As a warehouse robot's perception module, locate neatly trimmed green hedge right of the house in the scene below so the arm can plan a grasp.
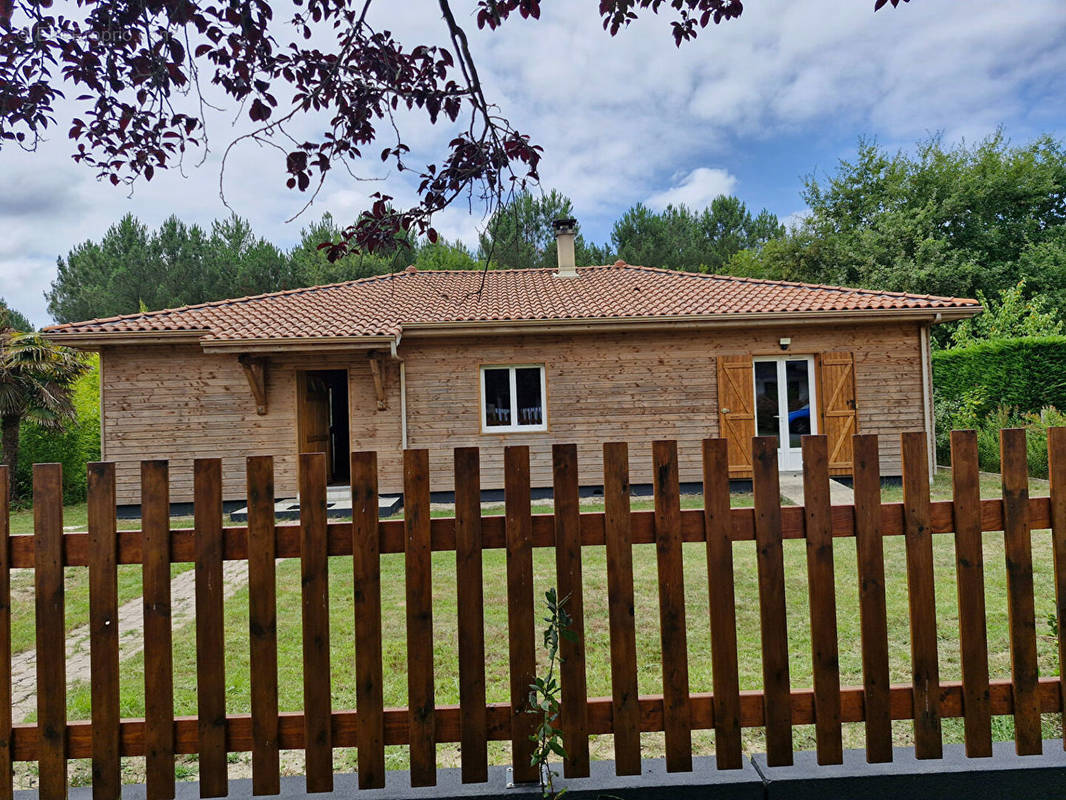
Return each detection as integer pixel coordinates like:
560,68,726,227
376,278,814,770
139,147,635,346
933,336,1066,414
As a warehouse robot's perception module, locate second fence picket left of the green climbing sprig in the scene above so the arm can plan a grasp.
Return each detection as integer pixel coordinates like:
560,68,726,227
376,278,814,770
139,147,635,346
454,447,488,783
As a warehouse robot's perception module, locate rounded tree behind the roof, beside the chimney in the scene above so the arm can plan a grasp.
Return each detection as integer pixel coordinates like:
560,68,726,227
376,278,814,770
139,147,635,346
478,189,608,269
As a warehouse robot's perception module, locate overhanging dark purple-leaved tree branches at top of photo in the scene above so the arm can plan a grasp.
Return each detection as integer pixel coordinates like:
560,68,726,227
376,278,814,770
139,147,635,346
0,0,899,258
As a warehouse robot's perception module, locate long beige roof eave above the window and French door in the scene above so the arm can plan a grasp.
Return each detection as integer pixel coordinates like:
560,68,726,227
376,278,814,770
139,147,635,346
404,306,983,337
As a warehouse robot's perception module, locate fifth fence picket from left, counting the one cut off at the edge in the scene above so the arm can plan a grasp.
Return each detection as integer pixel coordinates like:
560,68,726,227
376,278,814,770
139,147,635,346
193,459,228,797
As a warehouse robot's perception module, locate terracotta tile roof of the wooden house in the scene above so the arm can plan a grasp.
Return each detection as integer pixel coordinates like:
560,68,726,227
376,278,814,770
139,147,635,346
46,262,980,341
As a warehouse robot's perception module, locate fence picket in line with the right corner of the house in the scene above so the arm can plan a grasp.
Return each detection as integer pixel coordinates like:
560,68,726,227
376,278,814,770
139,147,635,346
900,431,943,758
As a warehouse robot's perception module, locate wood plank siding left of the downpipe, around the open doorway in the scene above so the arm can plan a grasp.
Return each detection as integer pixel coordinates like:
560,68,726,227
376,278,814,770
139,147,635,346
100,345,401,505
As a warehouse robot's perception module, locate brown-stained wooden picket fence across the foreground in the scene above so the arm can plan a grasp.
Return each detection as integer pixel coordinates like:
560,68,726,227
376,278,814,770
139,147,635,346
0,429,1066,798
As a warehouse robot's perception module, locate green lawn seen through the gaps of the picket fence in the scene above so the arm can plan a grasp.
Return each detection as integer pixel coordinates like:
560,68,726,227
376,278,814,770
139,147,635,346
10,471,1061,780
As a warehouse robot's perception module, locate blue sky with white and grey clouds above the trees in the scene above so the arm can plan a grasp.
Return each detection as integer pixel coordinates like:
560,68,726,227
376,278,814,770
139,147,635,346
0,0,1066,324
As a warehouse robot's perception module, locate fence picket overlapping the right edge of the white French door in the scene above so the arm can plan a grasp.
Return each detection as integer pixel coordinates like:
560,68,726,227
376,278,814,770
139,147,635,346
802,435,844,764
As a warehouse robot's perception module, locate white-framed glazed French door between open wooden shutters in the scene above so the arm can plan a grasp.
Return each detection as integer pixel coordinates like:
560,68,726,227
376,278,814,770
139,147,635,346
754,355,818,471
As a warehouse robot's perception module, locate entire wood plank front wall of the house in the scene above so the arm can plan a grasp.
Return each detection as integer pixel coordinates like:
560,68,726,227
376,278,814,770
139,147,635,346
101,323,925,503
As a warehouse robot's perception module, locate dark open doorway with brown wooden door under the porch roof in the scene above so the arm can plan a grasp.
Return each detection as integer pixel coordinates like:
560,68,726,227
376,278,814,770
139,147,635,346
296,369,351,483
